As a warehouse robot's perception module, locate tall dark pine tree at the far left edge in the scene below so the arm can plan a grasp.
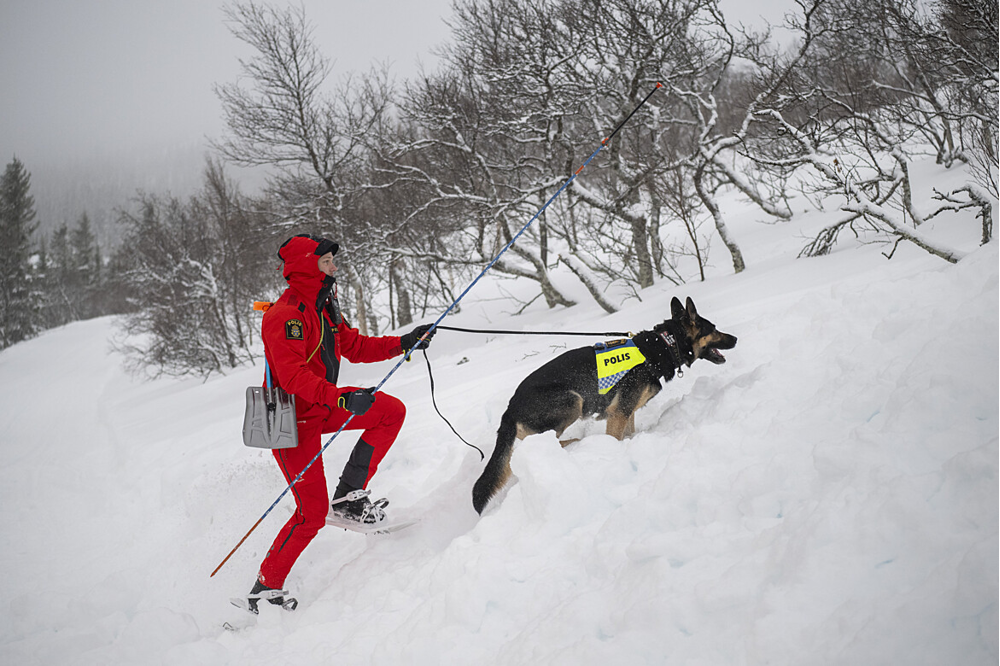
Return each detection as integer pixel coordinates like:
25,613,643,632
0,157,38,349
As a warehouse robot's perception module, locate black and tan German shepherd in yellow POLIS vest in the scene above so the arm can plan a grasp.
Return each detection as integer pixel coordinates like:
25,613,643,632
472,297,736,513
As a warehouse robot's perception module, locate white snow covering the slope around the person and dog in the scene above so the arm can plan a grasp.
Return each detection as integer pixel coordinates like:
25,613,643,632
0,158,1000,666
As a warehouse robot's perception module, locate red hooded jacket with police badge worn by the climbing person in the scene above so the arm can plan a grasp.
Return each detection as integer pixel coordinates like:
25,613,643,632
261,236,403,417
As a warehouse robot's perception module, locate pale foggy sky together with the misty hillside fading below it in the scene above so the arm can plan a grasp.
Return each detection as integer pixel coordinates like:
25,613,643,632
0,0,793,243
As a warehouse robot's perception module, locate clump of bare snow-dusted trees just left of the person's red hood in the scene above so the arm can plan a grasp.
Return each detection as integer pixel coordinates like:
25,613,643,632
115,162,278,376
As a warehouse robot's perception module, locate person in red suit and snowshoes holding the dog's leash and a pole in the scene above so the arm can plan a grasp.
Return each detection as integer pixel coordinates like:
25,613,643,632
251,235,434,610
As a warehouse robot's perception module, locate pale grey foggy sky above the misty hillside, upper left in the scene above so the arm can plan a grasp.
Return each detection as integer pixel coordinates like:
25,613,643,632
0,0,450,167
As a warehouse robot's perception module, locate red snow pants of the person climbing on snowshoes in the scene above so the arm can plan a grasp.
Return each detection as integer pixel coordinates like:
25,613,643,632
260,388,406,588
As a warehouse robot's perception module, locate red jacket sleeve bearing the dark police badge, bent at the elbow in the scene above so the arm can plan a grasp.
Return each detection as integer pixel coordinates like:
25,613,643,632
261,306,343,407
